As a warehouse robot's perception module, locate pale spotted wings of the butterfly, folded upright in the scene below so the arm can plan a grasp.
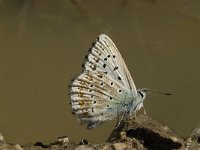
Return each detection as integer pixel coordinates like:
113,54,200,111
71,34,137,129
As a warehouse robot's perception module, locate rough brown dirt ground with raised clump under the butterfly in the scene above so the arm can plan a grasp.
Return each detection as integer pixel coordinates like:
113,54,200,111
0,115,200,150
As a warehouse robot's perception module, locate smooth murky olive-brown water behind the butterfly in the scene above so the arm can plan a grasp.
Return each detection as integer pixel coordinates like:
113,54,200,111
0,0,200,144
